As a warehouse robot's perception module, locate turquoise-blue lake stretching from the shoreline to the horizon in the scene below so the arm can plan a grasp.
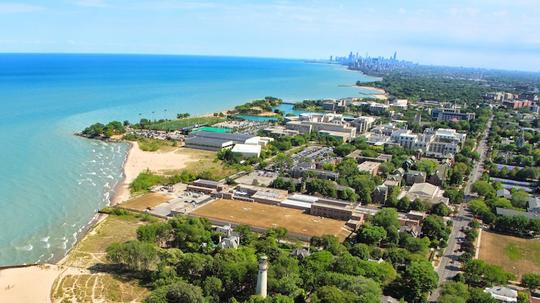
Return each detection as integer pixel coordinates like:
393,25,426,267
0,54,378,265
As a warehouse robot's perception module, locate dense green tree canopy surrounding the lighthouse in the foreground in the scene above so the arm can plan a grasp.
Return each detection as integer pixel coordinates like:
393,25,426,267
107,208,447,303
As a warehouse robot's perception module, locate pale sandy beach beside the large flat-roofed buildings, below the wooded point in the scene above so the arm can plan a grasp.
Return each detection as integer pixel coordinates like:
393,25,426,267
111,142,200,205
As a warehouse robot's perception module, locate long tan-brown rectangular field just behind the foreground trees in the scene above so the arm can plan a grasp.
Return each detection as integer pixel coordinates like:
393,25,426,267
192,199,348,239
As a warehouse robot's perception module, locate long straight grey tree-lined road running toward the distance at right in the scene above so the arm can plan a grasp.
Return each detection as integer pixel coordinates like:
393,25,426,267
429,117,493,302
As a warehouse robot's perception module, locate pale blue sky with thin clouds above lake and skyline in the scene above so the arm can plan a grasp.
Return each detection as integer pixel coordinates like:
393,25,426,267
0,0,540,71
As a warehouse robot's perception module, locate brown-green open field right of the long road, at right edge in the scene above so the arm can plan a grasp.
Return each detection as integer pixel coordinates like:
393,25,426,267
479,231,540,279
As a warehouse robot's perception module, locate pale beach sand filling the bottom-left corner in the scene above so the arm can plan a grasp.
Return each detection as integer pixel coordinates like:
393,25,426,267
0,265,63,303
